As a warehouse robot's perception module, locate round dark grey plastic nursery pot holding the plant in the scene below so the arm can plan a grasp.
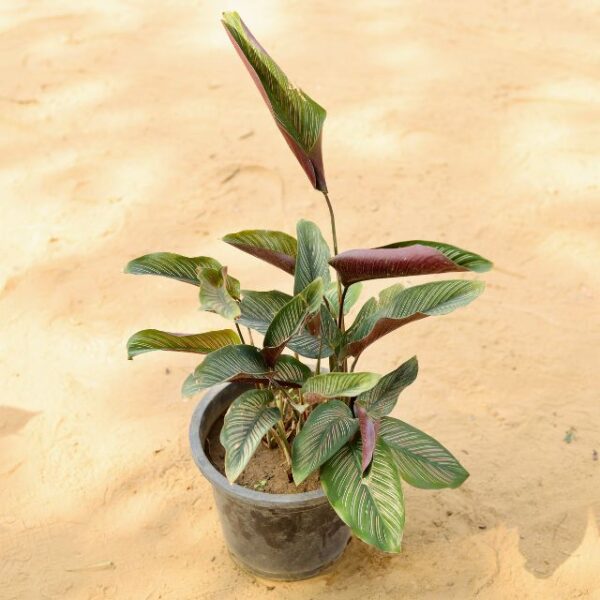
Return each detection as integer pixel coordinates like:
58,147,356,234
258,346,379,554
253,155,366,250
190,383,350,580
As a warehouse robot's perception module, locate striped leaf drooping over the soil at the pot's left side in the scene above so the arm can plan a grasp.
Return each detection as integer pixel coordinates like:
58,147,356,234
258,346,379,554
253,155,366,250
221,390,281,483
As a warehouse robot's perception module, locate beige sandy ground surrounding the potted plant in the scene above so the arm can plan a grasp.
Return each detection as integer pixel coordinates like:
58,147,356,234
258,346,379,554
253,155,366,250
0,0,600,600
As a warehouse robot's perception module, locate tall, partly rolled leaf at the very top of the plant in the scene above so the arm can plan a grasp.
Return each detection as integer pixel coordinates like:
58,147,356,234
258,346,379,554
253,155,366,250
222,12,327,191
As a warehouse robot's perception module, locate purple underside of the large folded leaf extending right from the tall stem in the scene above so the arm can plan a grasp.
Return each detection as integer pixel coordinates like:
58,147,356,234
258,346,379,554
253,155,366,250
329,244,468,286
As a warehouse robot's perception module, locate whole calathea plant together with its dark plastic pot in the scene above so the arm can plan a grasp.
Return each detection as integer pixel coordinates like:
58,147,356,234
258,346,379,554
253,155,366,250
126,13,491,579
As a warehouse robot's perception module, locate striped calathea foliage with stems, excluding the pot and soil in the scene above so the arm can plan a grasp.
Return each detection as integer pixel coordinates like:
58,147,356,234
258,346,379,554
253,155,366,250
126,13,491,552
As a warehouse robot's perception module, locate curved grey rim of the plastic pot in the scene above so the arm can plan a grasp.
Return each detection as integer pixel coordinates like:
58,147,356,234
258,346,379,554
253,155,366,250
189,383,328,509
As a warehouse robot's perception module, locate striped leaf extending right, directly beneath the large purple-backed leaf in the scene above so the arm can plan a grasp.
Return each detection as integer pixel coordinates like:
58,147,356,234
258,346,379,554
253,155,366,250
344,279,485,356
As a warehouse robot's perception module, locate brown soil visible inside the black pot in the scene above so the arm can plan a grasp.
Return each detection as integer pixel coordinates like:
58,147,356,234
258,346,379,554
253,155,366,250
205,417,321,494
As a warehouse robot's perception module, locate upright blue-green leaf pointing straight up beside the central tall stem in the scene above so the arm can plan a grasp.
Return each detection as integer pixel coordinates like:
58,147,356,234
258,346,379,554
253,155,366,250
294,219,331,294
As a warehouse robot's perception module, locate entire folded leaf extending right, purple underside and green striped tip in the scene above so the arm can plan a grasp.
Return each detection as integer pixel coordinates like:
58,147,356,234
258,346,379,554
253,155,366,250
329,241,492,285
